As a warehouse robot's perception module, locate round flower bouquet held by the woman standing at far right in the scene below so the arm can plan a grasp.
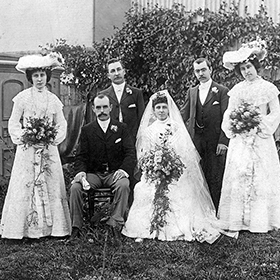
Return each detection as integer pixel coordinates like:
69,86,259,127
229,101,261,134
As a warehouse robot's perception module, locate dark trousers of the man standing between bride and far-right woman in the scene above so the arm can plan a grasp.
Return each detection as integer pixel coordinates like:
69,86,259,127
194,133,226,210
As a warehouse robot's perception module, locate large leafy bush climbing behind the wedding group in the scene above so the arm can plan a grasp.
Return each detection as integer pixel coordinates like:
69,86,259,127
49,3,280,105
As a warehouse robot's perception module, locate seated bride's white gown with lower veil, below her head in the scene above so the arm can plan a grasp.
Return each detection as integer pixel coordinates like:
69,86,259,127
122,119,220,243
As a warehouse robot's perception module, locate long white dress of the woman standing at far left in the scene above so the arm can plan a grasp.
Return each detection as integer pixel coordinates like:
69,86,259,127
0,87,71,239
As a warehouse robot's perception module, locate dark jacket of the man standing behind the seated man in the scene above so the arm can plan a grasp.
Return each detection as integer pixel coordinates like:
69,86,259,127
99,84,145,141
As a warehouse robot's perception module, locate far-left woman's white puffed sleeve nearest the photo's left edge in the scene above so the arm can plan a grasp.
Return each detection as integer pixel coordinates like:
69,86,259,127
8,97,23,145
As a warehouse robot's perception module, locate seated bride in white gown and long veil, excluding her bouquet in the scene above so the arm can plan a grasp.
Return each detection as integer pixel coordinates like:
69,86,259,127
122,90,220,243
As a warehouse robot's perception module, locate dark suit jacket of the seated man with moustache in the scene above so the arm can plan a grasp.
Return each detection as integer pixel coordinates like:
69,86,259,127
75,120,136,176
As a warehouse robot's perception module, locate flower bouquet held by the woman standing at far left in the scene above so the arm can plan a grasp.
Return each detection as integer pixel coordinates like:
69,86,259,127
21,116,57,148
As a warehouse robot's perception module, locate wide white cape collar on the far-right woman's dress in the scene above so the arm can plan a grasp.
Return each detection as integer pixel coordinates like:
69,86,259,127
228,77,279,106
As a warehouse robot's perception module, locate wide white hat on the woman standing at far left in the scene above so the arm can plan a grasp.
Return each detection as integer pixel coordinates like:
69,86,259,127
16,52,64,73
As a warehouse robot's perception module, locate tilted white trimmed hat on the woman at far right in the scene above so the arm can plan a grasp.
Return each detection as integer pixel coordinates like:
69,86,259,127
223,38,267,70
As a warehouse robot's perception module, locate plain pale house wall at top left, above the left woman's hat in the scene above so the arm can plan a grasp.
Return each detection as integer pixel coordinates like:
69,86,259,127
0,0,131,53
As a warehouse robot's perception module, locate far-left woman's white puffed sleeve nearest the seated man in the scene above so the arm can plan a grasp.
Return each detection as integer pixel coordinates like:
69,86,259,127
51,98,67,145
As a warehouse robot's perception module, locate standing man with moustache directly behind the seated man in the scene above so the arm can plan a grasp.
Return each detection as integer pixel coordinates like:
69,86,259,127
100,58,145,142
